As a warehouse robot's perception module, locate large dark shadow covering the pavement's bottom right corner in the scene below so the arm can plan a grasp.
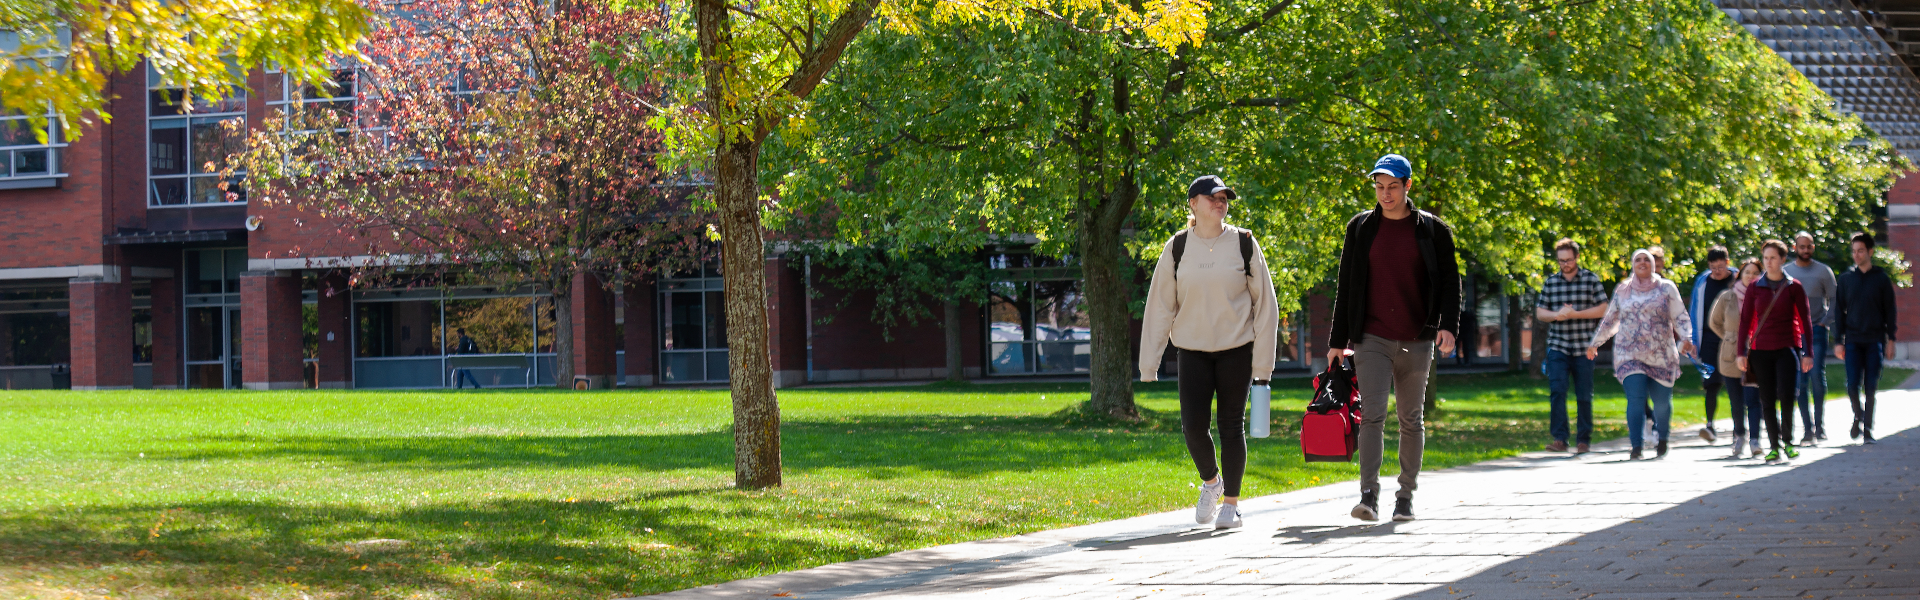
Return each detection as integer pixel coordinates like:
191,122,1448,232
1397,431,1920,600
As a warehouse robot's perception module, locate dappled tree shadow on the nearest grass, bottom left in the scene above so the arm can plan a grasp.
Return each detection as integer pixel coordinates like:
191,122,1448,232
0,490,952,598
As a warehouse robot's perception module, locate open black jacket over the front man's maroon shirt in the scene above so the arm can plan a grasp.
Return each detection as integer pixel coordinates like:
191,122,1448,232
1327,208,1459,348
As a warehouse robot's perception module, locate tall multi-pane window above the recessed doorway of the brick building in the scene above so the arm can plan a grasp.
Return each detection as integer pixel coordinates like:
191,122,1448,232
146,67,246,206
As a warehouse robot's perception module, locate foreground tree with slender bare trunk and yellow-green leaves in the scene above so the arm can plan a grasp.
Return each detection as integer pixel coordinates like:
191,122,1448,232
652,0,1206,488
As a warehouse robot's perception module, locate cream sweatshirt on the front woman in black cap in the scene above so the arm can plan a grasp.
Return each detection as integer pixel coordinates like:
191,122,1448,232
1140,225,1281,381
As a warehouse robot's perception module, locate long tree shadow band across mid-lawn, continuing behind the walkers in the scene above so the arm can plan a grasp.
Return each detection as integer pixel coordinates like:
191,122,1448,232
144,402,1613,479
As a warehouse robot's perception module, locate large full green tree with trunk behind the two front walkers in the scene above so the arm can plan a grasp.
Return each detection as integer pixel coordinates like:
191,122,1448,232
778,0,1893,417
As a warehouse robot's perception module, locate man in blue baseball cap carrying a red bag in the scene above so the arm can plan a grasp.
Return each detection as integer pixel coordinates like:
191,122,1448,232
1327,154,1459,521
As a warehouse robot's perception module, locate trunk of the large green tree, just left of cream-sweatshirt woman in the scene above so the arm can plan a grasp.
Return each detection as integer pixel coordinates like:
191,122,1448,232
1079,181,1140,419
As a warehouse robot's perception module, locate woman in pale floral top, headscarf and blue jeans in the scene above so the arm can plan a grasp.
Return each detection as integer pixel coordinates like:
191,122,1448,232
1586,250,1693,460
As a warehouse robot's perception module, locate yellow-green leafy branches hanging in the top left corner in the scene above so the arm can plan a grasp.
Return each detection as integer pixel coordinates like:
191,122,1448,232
0,0,372,138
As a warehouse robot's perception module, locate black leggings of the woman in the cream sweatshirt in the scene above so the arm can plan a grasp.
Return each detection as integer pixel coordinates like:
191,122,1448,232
1181,344,1254,498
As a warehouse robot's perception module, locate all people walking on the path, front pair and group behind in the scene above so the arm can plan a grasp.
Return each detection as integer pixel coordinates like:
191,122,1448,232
1139,154,1895,529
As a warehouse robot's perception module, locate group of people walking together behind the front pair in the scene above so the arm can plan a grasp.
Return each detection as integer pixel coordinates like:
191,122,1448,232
1534,233,1895,463
